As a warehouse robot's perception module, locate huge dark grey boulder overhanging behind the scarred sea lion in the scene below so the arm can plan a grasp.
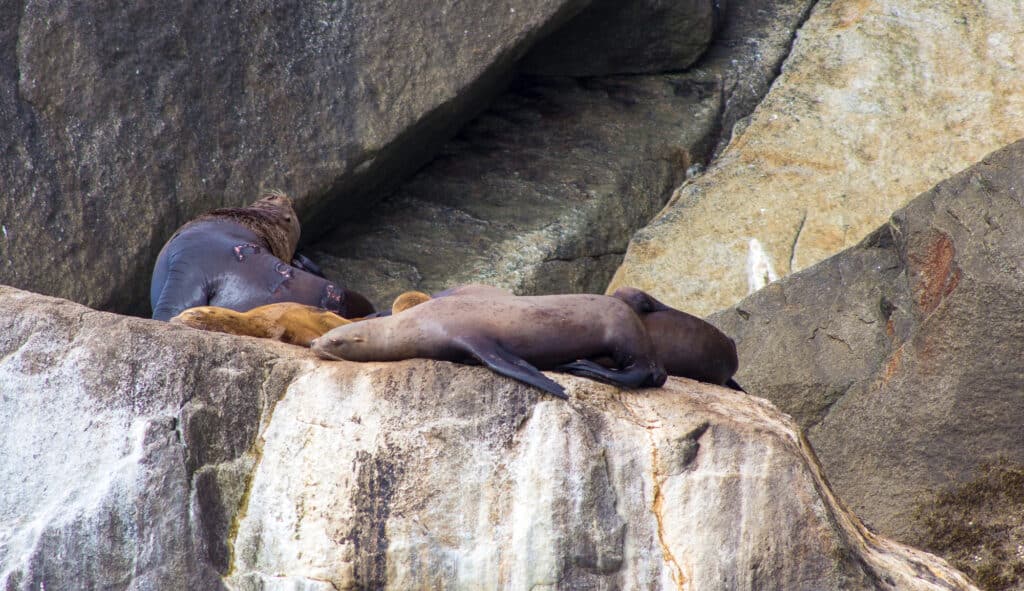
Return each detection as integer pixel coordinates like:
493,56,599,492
0,0,587,313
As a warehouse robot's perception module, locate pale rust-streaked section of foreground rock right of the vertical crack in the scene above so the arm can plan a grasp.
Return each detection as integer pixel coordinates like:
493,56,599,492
228,361,972,590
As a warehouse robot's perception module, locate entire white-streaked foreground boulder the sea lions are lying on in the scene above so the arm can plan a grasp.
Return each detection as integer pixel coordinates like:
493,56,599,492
0,288,975,591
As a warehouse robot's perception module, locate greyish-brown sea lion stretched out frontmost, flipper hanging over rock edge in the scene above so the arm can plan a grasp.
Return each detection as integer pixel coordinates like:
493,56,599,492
311,293,666,398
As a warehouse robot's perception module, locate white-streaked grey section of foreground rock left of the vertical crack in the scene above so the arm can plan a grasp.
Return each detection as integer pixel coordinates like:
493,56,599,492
0,287,307,591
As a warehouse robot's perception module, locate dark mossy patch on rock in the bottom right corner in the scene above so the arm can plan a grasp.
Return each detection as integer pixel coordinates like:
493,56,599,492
918,458,1024,591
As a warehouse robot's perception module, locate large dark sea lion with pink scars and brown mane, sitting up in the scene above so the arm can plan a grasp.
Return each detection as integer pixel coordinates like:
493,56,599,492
150,193,374,321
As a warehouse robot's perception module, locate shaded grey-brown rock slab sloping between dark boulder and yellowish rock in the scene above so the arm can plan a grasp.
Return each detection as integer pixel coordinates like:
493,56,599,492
303,0,810,306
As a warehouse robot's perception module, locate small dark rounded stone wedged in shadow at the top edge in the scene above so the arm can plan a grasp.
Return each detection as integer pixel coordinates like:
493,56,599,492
520,0,721,76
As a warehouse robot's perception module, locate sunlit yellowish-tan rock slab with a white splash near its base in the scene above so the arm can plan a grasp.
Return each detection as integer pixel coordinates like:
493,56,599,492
609,0,1024,314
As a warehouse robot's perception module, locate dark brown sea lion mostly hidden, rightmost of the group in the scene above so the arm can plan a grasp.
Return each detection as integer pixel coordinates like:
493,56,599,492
611,287,744,391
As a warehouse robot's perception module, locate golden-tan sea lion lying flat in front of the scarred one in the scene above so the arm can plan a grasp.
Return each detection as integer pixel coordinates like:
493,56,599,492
170,302,352,347
